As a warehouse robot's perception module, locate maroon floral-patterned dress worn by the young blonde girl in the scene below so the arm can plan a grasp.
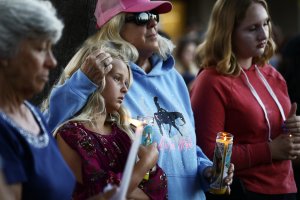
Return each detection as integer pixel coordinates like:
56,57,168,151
57,122,167,200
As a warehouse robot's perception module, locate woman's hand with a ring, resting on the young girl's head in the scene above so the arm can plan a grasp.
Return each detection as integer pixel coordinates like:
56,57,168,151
80,49,113,86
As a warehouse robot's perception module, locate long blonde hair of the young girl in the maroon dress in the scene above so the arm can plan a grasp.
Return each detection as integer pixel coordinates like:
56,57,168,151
43,41,135,137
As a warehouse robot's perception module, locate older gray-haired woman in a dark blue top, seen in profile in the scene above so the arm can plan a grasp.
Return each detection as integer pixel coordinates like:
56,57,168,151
0,0,75,200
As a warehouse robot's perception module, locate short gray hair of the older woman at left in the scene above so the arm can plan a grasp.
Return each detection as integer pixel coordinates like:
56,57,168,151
0,0,63,58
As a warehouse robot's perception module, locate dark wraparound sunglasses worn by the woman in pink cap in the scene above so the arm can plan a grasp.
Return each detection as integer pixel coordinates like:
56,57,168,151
125,12,159,26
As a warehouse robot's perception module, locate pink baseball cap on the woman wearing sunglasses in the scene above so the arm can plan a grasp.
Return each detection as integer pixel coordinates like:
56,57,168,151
95,0,172,28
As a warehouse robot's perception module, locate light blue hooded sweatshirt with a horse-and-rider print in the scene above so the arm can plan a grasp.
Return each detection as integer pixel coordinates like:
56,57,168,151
45,55,212,200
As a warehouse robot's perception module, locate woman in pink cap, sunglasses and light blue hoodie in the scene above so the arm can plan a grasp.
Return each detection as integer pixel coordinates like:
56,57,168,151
46,0,234,200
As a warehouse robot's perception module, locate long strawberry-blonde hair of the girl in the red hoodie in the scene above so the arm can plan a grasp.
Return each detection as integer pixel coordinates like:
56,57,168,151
197,0,276,76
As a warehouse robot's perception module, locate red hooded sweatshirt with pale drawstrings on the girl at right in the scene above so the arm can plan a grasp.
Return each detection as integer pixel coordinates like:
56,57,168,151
191,65,297,194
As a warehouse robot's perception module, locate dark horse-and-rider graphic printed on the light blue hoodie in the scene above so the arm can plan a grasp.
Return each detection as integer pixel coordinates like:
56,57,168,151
154,97,186,137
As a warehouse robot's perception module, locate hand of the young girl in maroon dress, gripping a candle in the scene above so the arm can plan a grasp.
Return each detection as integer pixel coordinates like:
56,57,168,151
138,143,158,170
